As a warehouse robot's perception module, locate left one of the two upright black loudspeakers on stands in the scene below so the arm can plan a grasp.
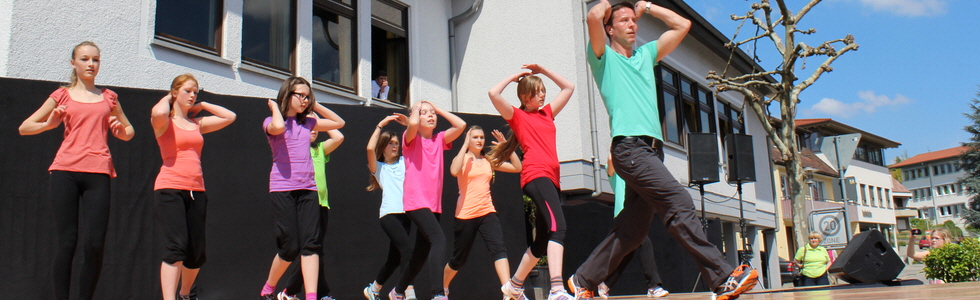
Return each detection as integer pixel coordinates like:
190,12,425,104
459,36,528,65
687,133,720,184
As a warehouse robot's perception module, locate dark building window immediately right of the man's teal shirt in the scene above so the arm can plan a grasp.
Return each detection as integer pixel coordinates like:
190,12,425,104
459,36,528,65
656,66,715,145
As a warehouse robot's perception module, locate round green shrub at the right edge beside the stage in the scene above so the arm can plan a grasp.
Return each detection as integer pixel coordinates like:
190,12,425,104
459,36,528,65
923,238,980,282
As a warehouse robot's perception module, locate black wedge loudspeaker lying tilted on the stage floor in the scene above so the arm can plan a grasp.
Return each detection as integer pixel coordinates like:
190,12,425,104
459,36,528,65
828,230,905,283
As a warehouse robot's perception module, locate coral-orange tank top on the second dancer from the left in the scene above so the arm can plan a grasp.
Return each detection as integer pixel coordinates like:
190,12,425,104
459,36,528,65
153,120,204,192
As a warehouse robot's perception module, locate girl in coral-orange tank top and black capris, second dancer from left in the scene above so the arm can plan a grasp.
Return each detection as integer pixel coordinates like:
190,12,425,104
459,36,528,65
150,74,235,300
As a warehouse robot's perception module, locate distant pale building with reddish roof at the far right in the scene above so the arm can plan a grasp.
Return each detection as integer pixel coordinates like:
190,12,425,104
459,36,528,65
888,146,970,232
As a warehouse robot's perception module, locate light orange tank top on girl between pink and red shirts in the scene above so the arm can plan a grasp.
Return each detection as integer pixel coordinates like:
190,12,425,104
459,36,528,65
456,154,497,220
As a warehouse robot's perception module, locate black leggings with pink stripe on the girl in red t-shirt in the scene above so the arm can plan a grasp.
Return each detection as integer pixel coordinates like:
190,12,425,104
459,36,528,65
524,177,565,258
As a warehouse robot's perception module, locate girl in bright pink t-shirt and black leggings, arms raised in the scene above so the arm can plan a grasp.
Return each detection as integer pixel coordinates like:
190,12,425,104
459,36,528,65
388,101,466,300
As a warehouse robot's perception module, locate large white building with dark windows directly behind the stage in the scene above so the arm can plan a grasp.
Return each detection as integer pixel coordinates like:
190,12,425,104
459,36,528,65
0,0,780,286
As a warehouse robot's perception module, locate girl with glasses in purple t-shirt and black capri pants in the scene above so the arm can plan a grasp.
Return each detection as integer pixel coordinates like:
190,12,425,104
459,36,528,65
260,76,344,300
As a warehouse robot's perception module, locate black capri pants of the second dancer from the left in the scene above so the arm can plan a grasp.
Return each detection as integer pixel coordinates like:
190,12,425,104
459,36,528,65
153,189,208,269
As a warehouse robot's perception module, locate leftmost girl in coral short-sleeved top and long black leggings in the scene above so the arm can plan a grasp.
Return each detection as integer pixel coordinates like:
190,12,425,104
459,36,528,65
19,41,134,299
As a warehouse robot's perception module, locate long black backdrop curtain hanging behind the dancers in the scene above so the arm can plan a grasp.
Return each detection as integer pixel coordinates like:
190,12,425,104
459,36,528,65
0,78,712,299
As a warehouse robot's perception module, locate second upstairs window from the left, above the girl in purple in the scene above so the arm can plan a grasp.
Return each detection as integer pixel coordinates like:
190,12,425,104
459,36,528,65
242,0,296,73
